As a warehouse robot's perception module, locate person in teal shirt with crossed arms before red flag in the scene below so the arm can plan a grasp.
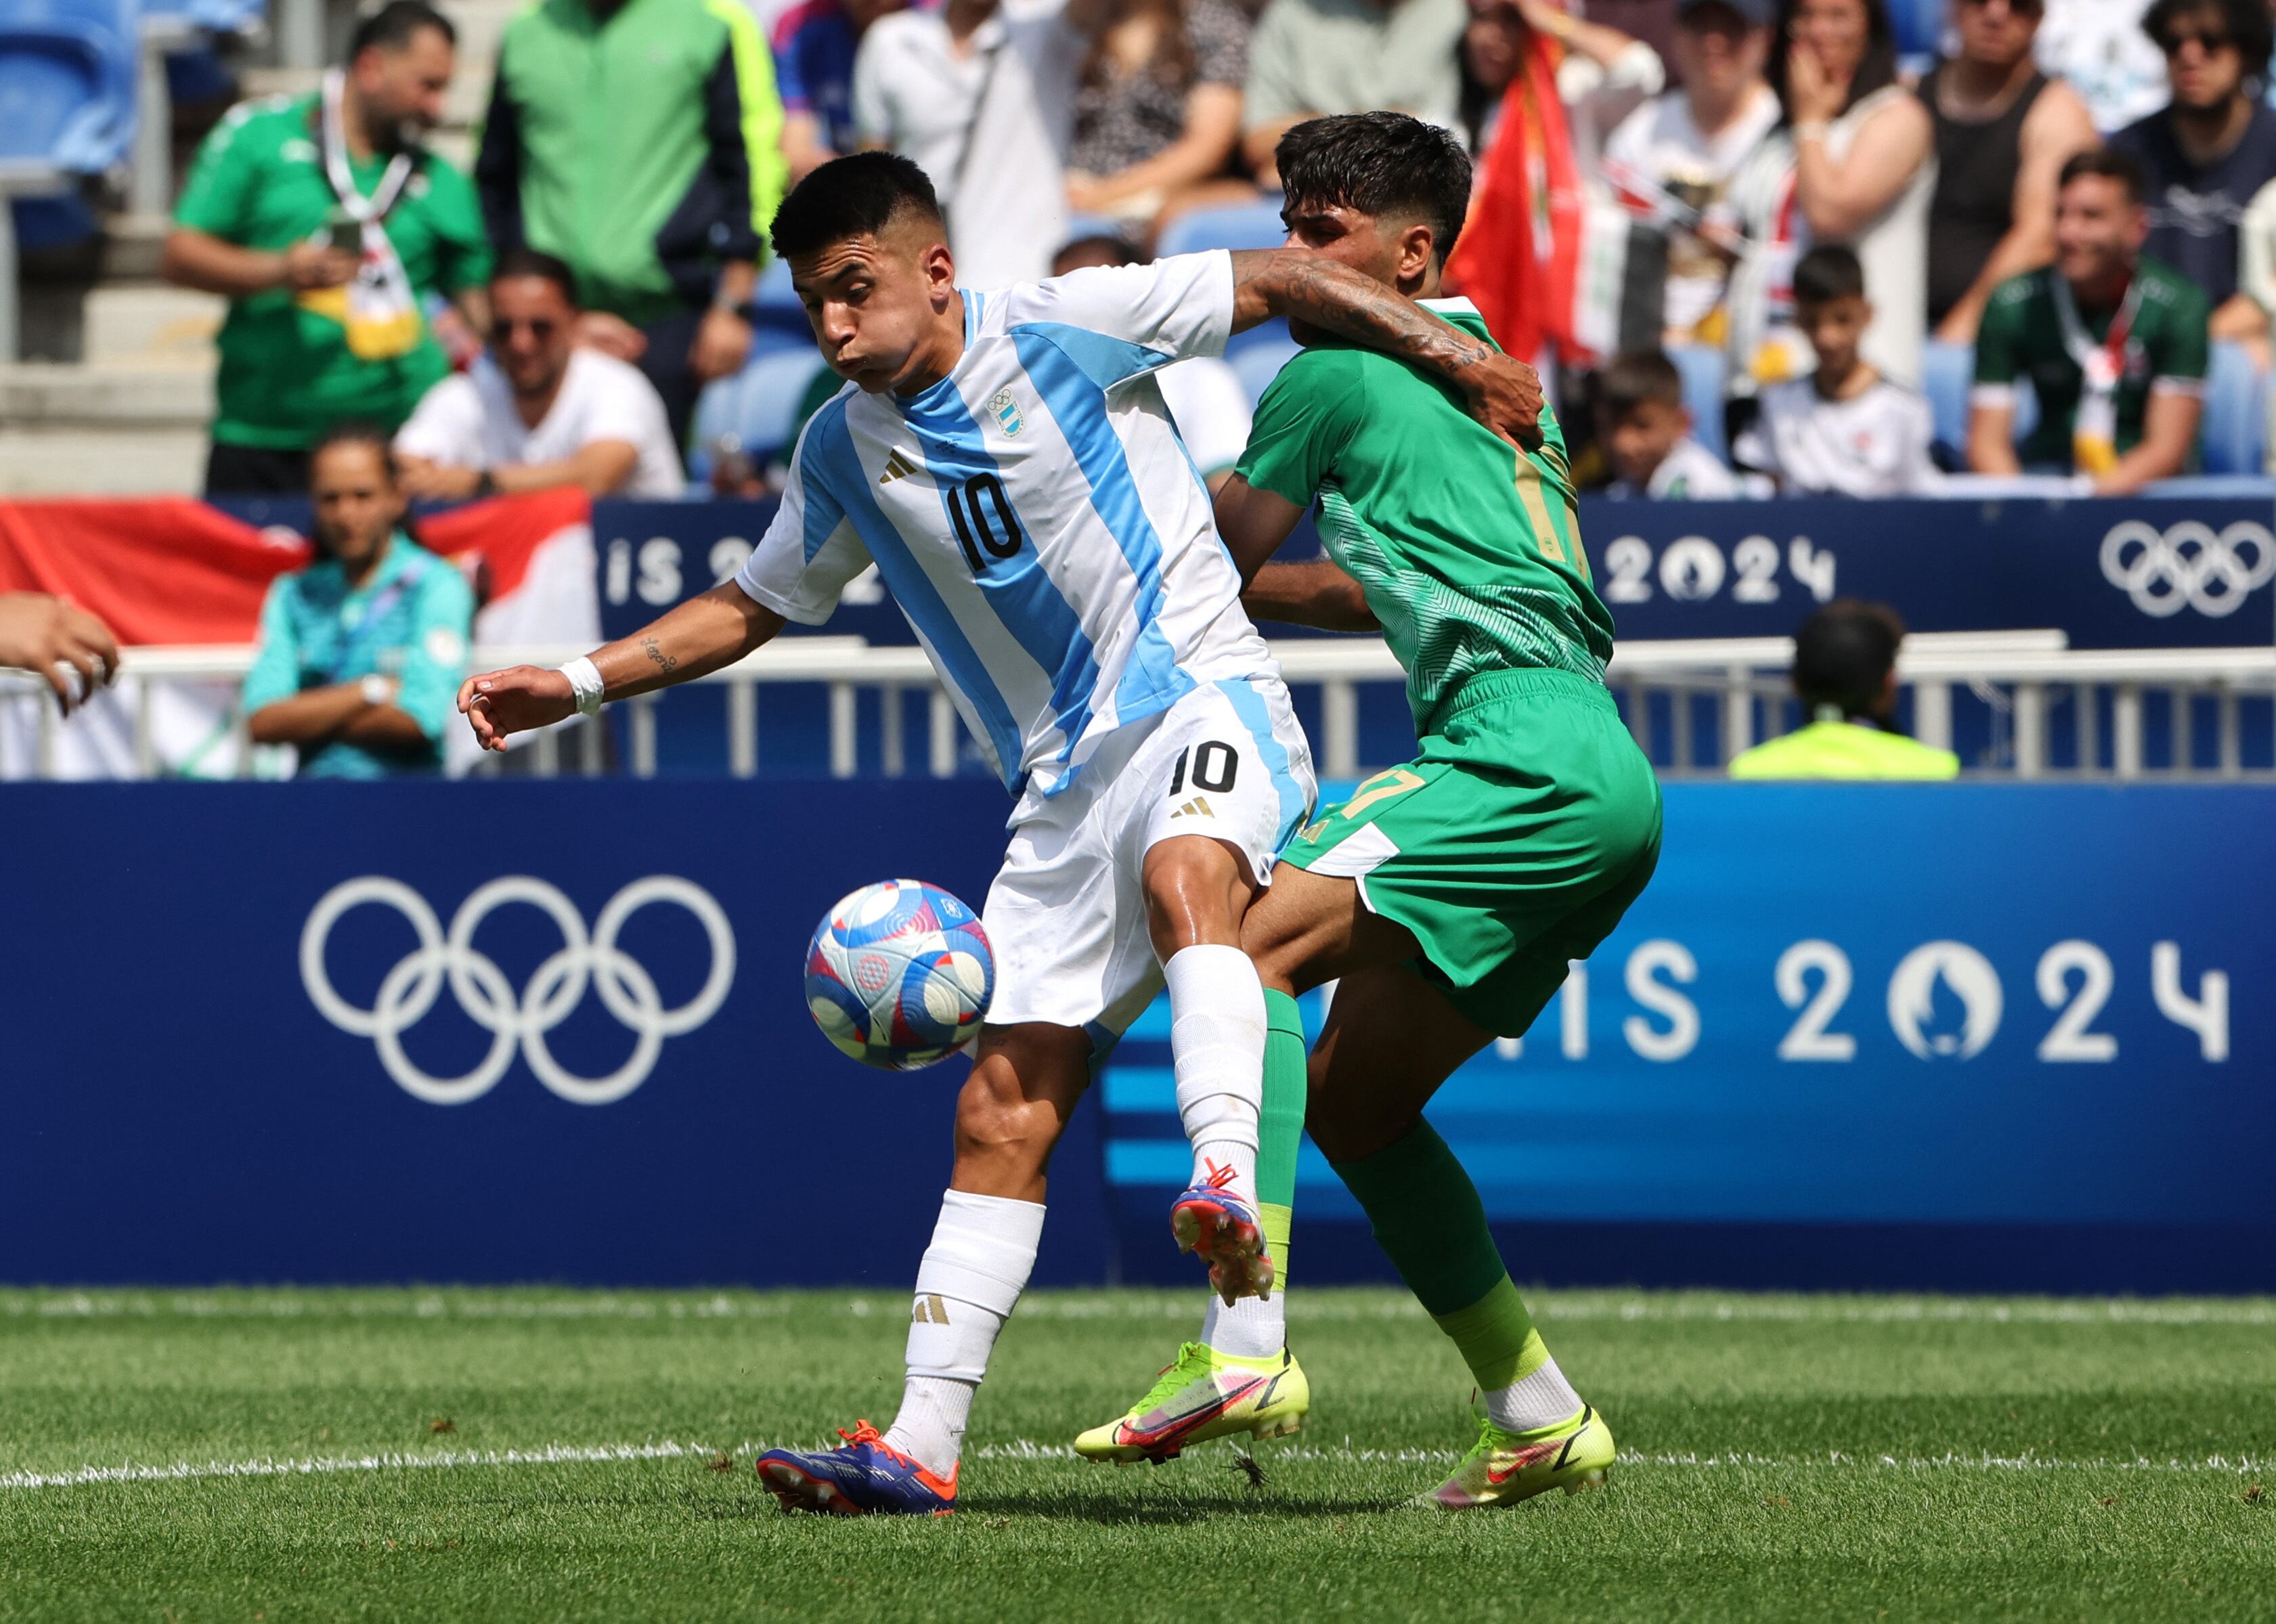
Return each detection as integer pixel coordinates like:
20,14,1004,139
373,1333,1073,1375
241,425,473,778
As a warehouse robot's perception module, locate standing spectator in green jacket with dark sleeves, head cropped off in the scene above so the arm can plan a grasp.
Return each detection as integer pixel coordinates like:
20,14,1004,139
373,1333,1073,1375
473,0,783,446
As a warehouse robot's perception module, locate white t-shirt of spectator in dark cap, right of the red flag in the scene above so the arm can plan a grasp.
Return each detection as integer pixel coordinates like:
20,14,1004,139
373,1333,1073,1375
1604,84,1778,343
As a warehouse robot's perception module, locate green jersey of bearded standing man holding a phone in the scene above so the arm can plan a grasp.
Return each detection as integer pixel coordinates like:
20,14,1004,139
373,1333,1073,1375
173,95,489,450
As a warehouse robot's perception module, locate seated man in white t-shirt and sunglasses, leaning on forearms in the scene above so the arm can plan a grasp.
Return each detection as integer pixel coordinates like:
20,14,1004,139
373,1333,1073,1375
396,248,687,503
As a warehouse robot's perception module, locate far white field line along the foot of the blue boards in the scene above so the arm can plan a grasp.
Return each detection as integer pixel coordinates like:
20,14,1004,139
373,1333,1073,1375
0,1290,2276,1326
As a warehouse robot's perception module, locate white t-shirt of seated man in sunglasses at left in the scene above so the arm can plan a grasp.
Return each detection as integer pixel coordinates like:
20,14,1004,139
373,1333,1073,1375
396,350,687,500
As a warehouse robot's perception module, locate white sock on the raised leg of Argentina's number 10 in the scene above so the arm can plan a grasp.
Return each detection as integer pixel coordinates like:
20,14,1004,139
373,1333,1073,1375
1161,946,1265,1208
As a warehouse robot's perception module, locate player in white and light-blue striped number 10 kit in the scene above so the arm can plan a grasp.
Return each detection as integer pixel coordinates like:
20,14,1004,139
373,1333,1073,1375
460,152,1541,1512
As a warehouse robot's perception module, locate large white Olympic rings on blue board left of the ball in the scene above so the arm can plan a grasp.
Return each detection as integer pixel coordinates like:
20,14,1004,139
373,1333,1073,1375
301,873,735,1105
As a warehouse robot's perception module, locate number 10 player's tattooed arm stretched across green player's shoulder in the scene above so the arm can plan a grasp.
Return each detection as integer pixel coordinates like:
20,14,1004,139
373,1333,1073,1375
1233,248,1541,450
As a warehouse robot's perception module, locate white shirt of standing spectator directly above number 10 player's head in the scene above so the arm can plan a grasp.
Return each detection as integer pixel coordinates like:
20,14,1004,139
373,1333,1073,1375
854,9,1081,286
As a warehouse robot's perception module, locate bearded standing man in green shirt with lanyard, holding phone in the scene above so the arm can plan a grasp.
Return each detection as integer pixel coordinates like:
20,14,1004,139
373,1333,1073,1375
164,0,489,496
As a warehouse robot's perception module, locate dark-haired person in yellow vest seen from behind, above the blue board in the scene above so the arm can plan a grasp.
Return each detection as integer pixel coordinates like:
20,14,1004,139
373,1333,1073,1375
1730,598,1960,778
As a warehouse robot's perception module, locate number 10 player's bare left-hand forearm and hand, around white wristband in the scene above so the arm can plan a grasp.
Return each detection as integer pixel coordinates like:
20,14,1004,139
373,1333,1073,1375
458,580,783,751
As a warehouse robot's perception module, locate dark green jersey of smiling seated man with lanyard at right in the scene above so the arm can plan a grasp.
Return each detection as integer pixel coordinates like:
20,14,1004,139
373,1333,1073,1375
1975,259,2208,468
